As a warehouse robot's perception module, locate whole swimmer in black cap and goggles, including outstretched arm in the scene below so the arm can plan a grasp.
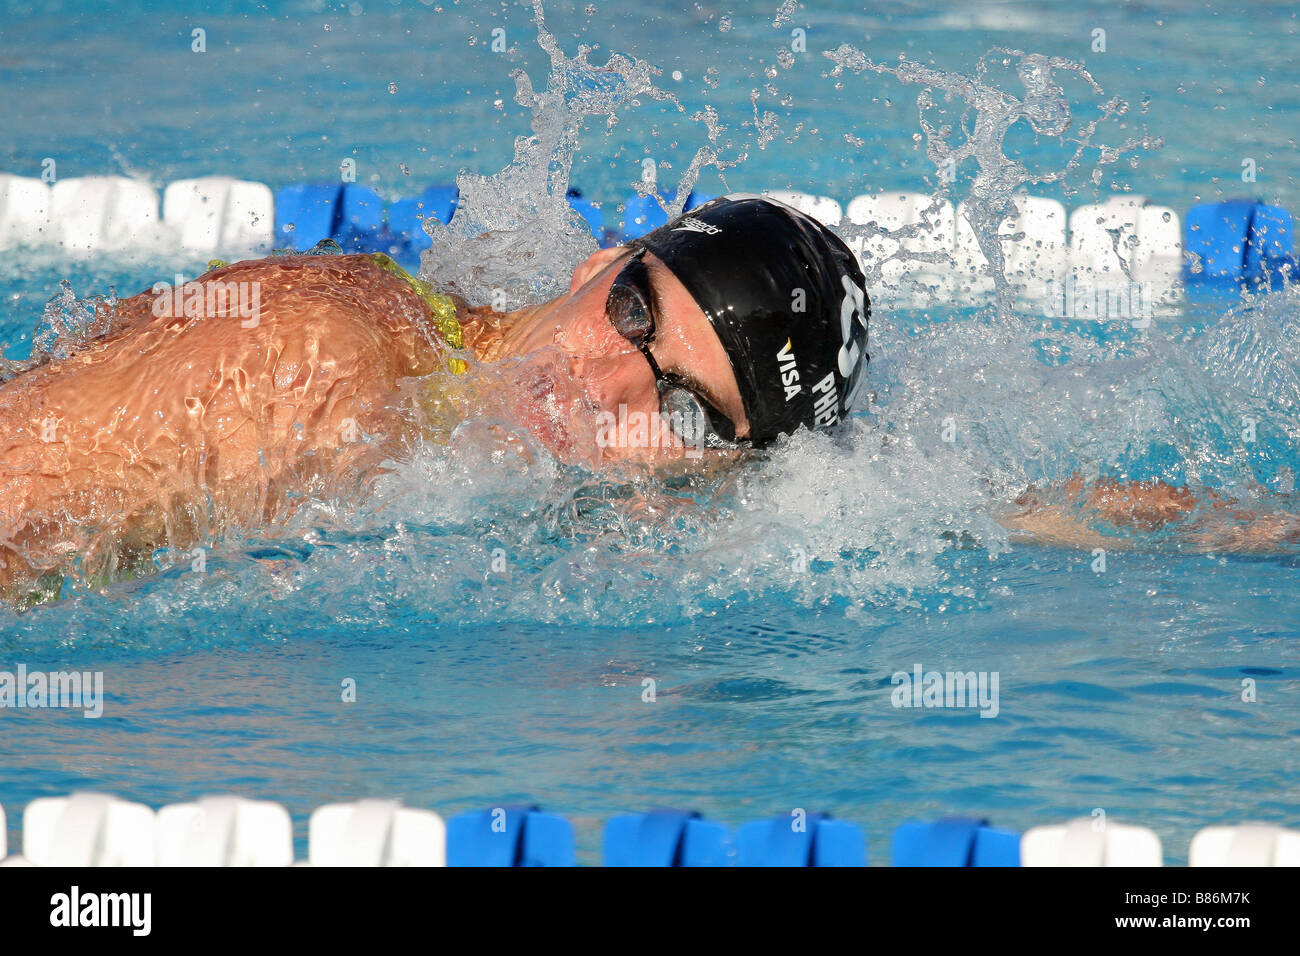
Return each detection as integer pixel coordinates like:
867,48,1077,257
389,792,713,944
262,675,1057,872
0,194,1300,601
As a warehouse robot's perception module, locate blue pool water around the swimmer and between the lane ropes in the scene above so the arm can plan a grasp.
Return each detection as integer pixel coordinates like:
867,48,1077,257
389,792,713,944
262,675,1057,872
0,0,1300,862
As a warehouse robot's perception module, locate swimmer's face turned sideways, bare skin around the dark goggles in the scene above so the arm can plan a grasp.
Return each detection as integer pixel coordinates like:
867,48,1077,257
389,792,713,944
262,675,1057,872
517,247,749,462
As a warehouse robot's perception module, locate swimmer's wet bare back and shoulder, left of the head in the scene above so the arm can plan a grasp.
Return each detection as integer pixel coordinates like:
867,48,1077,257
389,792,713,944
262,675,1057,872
0,255,462,598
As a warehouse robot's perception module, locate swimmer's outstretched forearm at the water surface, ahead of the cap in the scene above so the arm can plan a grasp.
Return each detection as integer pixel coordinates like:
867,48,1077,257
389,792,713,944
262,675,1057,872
998,476,1300,553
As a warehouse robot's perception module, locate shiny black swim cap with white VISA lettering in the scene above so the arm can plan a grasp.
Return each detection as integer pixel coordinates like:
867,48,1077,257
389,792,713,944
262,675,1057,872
628,193,871,446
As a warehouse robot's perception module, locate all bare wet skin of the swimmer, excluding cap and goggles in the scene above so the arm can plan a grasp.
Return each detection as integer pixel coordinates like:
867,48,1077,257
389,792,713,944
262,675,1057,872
0,248,1297,594
